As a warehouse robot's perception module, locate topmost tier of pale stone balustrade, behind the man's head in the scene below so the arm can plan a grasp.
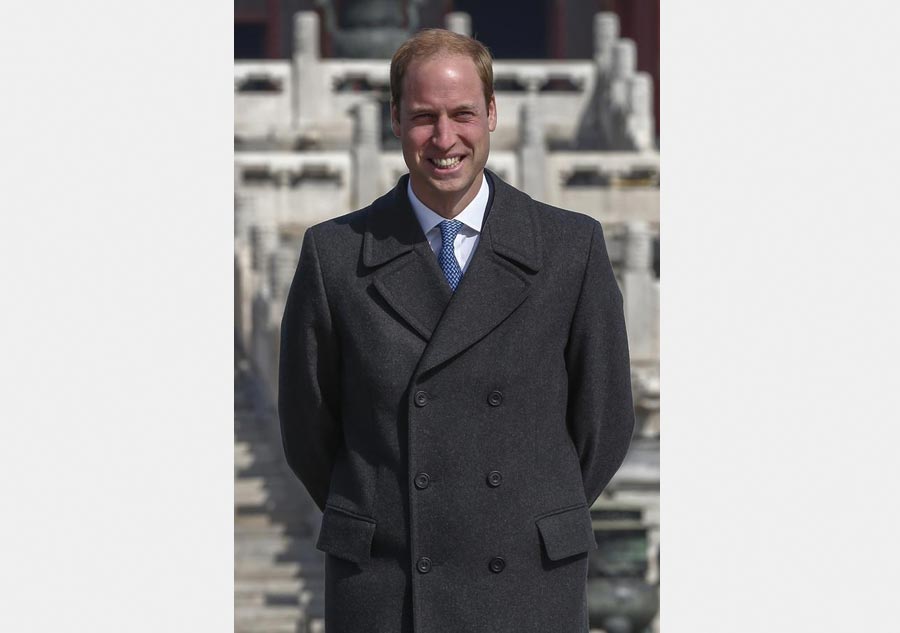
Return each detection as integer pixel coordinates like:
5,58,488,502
234,12,654,150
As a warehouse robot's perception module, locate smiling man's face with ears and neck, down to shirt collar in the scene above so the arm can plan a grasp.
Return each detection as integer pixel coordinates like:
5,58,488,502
391,56,497,217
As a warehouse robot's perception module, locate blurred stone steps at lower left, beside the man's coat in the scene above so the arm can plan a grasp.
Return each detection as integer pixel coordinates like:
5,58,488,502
234,350,325,633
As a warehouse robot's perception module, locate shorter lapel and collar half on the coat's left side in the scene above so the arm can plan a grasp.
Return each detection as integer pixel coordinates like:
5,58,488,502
363,176,453,341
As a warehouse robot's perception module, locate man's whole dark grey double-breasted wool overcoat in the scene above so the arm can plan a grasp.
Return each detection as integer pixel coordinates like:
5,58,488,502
278,172,634,633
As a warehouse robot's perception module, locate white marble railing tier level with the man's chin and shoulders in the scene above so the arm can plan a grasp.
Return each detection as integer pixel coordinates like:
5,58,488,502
235,150,659,233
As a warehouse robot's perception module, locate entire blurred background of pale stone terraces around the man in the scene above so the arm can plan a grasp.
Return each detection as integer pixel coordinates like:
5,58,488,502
234,0,660,633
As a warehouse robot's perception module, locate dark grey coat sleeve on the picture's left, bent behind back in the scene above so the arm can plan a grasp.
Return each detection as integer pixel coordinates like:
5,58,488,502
278,230,343,510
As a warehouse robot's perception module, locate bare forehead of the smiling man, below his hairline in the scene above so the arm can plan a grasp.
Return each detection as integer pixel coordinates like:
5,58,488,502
402,55,484,101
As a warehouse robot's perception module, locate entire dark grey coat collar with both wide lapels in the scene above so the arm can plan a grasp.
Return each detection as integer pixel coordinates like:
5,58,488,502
363,171,542,374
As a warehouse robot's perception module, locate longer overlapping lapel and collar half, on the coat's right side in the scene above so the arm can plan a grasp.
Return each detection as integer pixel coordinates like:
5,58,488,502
418,171,541,374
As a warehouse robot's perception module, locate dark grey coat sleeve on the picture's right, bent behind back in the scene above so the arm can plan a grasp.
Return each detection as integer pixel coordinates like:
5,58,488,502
566,222,634,506
